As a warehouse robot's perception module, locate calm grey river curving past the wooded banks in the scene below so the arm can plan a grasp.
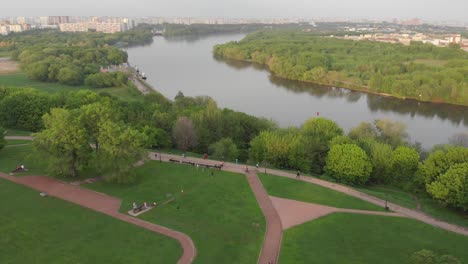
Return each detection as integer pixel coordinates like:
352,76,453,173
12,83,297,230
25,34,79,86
127,34,468,148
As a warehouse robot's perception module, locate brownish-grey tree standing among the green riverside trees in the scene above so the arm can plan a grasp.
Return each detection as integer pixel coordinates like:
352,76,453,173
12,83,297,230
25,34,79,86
172,116,197,151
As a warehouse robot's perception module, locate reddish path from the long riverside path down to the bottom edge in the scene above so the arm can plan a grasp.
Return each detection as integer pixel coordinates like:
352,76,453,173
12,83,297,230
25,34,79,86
246,172,283,264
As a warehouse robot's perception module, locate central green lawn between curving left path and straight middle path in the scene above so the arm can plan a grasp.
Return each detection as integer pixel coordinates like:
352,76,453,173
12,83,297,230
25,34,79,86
85,161,265,263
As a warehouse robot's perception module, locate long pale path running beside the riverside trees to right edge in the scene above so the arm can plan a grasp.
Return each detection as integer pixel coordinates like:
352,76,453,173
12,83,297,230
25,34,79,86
149,152,468,236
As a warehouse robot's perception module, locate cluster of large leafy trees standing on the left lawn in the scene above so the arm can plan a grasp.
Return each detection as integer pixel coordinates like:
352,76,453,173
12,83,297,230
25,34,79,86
33,100,146,183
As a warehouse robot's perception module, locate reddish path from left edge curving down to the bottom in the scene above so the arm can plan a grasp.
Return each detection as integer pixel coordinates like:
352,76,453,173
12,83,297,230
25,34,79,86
0,173,196,264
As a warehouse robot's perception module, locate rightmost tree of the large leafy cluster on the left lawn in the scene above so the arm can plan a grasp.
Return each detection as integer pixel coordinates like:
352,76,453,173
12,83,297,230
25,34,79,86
97,122,147,183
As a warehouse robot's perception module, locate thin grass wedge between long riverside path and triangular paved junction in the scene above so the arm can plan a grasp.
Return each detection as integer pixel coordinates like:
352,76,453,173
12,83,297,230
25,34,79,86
258,173,385,211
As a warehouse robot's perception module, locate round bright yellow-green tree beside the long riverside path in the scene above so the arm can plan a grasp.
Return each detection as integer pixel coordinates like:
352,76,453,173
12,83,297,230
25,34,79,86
325,144,372,184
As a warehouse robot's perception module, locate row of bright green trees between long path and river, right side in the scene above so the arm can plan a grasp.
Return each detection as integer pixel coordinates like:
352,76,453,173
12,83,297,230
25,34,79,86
249,118,468,210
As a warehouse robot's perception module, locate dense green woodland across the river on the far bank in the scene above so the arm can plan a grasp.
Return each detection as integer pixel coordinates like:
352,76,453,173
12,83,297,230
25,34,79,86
214,31,468,105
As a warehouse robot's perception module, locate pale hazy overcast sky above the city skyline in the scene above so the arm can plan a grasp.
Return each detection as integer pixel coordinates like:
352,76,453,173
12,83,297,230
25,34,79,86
0,0,468,22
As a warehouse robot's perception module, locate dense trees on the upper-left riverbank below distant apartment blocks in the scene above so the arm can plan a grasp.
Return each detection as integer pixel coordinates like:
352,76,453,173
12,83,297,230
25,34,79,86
0,27,152,88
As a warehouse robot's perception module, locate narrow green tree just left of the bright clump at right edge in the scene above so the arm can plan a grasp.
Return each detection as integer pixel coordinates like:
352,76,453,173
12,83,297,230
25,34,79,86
391,146,419,184
